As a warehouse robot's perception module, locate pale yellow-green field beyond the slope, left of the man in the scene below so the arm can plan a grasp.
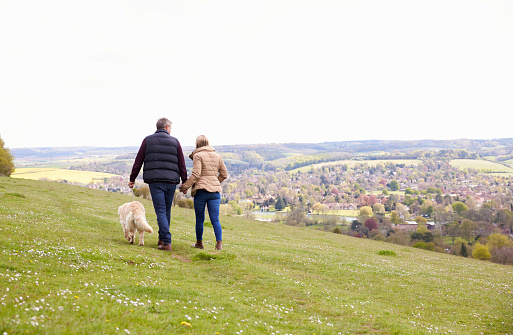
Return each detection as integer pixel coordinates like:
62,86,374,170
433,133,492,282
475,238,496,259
11,167,116,184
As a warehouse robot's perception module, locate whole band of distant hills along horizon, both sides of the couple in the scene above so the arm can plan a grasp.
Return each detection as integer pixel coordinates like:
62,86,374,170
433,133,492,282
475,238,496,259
11,138,513,171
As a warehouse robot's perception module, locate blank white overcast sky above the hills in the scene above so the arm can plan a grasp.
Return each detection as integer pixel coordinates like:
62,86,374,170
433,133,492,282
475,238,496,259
0,0,513,148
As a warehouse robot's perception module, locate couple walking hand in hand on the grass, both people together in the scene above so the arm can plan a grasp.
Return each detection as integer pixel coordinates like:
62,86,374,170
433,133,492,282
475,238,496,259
128,118,228,251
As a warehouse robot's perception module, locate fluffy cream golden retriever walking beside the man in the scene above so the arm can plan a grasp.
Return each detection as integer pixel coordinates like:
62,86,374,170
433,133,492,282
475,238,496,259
118,201,153,245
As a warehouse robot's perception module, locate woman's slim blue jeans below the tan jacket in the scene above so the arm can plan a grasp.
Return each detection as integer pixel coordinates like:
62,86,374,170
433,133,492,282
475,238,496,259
194,190,223,241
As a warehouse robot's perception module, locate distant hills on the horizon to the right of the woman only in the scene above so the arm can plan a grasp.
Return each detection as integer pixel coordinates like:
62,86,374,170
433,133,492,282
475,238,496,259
216,138,513,170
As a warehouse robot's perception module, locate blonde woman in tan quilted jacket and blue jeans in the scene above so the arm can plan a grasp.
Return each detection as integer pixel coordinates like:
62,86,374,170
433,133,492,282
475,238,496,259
180,135,228,250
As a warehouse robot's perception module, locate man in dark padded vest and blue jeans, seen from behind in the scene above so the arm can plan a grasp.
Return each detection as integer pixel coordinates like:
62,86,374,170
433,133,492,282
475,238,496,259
128,118,187,251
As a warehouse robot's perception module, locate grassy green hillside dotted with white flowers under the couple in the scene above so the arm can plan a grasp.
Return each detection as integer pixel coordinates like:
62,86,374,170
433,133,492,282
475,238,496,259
0,178,513,335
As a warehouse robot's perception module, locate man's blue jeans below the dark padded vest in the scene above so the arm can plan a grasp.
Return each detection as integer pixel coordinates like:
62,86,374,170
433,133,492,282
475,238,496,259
149,183,176,244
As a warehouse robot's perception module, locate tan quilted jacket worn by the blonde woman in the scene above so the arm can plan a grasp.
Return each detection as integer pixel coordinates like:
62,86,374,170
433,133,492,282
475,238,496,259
182,146,228,196
